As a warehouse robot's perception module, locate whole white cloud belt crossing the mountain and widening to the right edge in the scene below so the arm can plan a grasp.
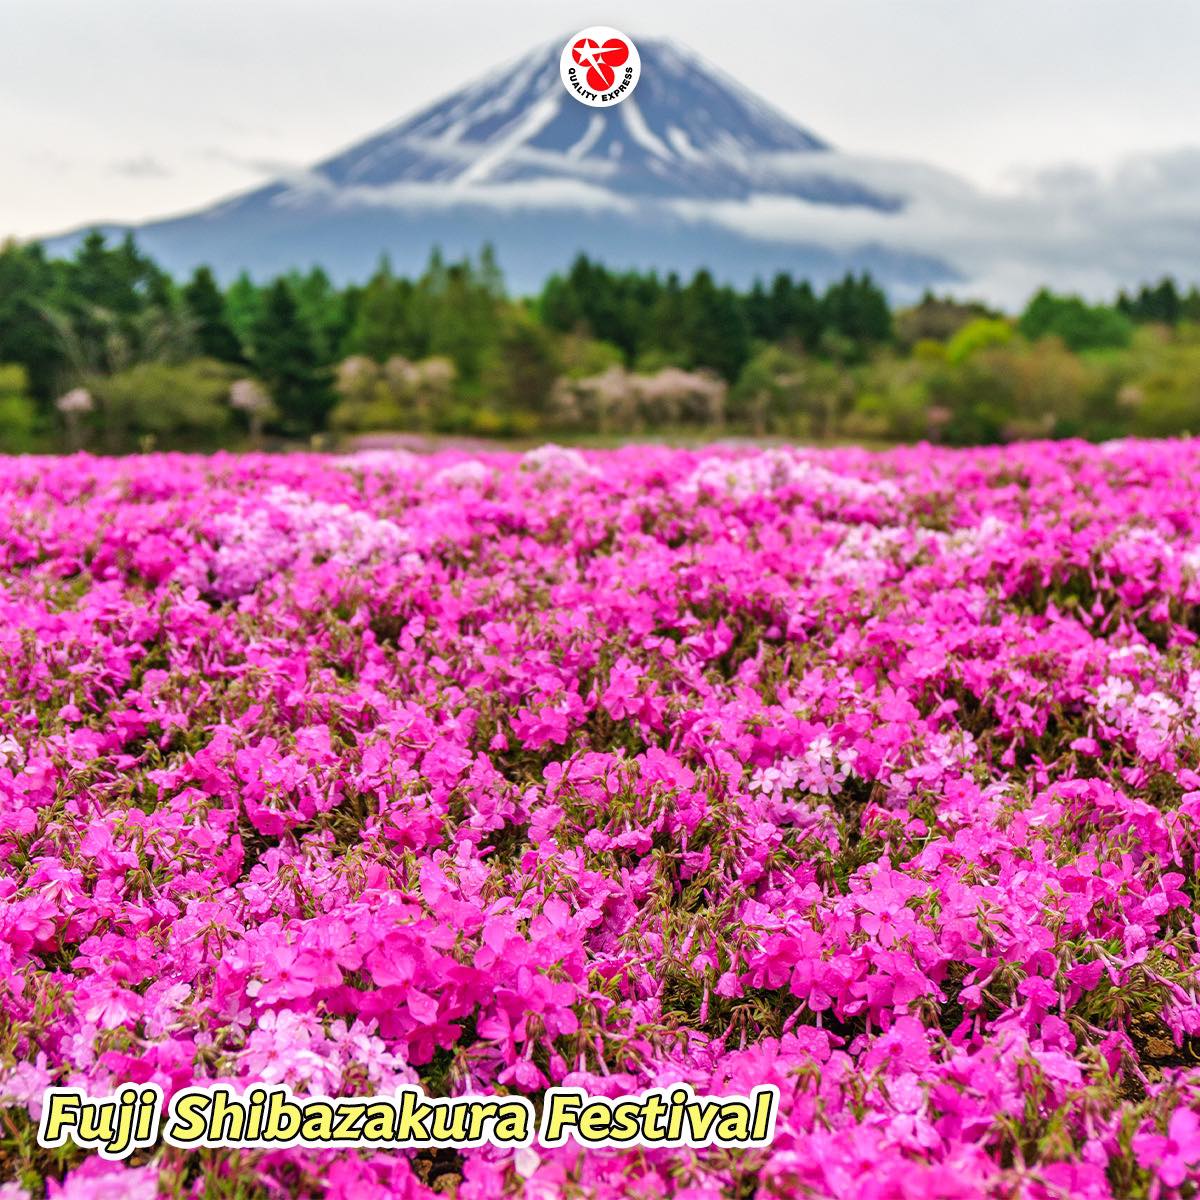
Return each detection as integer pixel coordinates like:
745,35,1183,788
243,146,1200,308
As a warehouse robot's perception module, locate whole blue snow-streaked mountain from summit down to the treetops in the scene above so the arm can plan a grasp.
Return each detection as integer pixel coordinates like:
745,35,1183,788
47,38,961,296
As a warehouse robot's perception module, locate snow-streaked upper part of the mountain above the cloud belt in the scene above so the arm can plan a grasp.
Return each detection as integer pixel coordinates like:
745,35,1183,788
307,38,899,209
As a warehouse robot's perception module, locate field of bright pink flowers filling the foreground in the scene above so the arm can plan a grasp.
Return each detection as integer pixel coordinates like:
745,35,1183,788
0,442,1200,1200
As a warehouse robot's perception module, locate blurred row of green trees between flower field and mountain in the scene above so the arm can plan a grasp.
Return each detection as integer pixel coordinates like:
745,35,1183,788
0,233,1200,452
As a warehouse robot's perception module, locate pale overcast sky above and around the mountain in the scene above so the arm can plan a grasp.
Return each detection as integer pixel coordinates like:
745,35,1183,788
0,0,1200,243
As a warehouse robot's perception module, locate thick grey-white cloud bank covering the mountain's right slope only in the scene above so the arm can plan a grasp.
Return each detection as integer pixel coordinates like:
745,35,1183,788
672,149,1200,307
